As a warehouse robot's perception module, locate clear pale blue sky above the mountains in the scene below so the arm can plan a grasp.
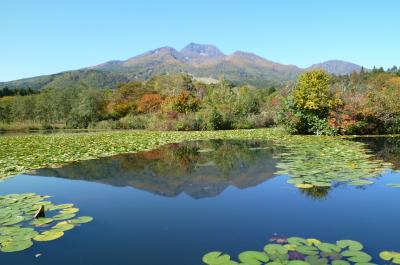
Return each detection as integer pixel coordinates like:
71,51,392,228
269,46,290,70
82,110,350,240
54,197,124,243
0,0,400,81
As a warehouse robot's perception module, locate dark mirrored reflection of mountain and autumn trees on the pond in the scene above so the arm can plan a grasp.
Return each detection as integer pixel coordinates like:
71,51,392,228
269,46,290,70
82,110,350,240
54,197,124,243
35,140,277,199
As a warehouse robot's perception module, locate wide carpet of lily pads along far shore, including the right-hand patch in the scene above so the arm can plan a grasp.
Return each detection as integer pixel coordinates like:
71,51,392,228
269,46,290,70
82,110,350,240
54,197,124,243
0,129,392,189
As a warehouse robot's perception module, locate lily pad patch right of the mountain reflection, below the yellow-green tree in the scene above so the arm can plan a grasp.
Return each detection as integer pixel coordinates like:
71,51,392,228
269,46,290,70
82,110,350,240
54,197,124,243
276,136,392,189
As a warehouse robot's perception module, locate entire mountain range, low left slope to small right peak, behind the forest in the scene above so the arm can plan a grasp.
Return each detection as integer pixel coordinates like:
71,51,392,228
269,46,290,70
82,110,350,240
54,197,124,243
0,43,361,89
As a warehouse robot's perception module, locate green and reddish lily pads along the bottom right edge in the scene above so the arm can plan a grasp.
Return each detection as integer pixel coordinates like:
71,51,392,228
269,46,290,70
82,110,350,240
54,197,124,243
203,237,390,265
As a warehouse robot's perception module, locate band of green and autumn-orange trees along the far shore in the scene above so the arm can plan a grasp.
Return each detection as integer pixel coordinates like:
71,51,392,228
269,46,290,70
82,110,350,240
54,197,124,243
0,67,400,135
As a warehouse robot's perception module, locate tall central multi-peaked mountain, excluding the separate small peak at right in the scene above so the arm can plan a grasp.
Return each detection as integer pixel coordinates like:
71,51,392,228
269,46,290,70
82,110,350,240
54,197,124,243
91,43,302,86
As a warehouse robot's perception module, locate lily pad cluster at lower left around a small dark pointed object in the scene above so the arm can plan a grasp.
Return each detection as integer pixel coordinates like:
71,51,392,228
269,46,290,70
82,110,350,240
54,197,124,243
0,193,93,252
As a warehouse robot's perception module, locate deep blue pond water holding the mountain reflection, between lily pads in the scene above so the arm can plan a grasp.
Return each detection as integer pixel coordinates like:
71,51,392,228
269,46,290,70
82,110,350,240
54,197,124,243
0,137,400,265
